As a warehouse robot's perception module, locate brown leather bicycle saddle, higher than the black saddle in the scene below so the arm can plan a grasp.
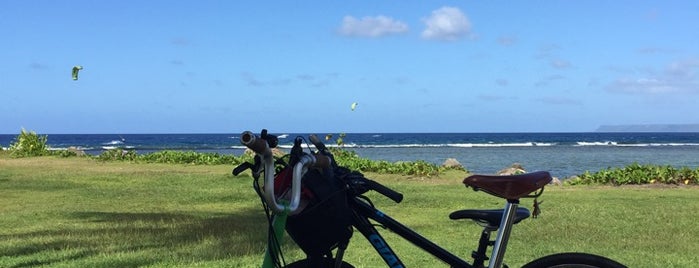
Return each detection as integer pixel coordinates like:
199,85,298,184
464,171,552,200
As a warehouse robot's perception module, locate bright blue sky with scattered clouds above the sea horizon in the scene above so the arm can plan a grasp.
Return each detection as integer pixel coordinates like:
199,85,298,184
0,0,699,134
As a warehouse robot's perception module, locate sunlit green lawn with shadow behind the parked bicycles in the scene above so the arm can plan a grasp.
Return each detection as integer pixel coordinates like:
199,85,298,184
0,156,699,267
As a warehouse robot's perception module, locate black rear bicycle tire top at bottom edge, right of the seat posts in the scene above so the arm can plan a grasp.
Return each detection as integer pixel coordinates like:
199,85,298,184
522,253,626,268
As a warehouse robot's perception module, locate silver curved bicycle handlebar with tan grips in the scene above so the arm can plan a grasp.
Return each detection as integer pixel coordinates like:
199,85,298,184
240,131,331,215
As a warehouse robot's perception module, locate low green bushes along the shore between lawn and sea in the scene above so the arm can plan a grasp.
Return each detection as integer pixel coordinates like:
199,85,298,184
8,129,699,185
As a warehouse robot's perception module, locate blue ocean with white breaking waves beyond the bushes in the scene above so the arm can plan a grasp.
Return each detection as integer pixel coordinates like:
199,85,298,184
0,131,699,178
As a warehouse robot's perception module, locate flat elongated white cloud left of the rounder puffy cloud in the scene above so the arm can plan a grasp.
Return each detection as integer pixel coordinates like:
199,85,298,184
339,16,408,37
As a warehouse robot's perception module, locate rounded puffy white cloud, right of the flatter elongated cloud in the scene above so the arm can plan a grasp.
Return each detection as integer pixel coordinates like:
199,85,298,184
422,7,471,41
